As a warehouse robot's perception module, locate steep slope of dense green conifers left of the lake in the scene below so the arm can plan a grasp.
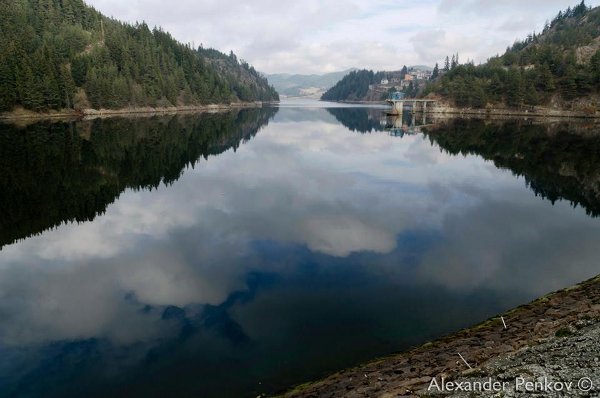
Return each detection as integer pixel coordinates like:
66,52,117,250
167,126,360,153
0,0,277,112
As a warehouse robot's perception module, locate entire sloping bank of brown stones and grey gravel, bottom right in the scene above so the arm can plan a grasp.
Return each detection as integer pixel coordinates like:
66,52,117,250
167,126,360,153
281,276,600,398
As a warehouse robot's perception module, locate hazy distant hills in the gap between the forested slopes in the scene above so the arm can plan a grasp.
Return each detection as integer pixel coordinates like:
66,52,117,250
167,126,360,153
267,69,355,97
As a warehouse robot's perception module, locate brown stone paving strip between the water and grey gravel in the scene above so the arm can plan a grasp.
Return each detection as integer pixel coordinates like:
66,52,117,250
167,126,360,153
277,275,600,398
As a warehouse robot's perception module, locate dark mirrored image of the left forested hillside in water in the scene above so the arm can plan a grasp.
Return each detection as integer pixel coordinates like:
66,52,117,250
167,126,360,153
0,108,277,247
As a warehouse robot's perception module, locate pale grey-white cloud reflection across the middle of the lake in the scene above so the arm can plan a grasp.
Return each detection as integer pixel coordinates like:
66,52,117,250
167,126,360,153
0,109,600,345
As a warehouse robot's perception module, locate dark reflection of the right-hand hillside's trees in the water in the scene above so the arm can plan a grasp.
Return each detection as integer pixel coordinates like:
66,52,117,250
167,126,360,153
426,120,600,217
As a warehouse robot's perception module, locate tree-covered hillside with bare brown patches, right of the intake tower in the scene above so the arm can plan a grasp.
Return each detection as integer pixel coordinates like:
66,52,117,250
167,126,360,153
423,1,600,109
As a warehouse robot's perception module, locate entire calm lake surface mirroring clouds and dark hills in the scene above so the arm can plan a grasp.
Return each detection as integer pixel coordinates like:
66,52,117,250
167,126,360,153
0,101,600,397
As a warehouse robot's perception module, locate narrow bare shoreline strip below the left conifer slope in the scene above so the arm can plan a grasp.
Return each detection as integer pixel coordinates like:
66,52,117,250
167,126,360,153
0,101,277,122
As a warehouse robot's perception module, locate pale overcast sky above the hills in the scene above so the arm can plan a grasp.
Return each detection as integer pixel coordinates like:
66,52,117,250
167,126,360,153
86,0,600,73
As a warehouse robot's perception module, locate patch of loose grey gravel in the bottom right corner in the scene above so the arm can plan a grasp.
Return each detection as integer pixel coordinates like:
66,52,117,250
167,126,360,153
444,318,600,398
